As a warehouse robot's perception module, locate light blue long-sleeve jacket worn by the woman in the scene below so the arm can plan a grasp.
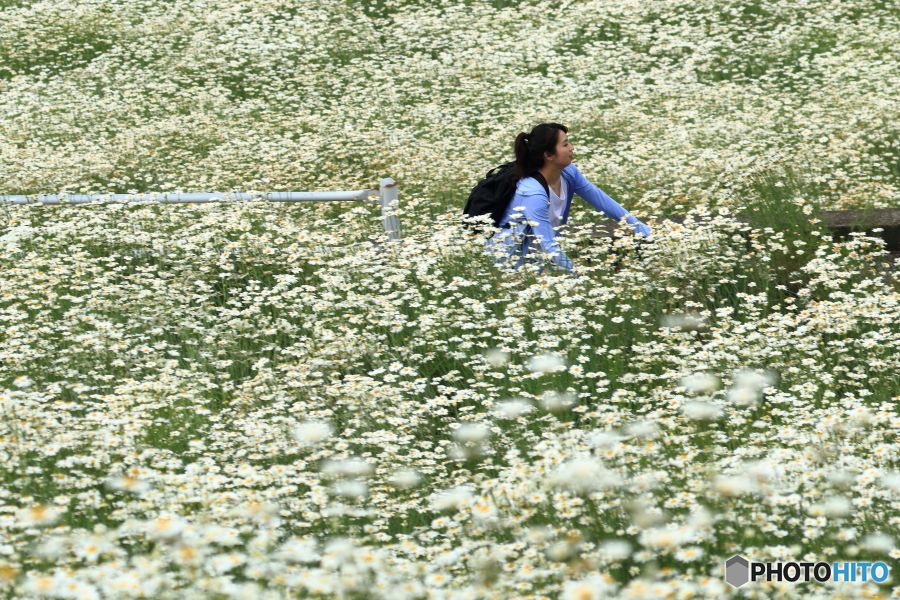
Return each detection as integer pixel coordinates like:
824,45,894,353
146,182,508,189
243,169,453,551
487,164,650,273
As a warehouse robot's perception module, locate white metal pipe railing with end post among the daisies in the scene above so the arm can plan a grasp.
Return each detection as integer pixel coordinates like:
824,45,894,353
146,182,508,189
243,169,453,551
0,177,400,240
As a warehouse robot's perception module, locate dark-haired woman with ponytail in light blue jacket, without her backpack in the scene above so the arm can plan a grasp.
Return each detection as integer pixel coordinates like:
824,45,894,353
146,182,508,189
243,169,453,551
487,123,650,273
